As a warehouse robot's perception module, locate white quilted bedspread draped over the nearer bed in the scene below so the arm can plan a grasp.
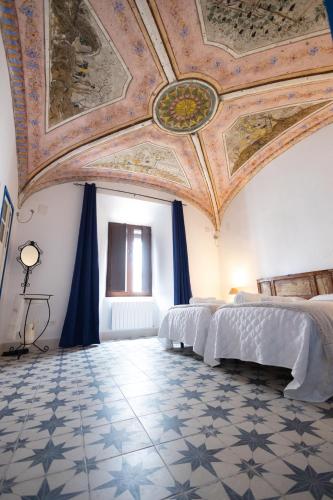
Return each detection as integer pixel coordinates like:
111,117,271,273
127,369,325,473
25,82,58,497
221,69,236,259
204,304,333,402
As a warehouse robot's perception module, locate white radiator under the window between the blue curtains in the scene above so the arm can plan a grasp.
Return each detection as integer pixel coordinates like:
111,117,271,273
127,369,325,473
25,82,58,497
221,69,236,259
111,302,156,330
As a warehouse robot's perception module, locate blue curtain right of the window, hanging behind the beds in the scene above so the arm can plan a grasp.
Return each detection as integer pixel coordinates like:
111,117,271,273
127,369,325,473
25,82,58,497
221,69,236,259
172,200,192,305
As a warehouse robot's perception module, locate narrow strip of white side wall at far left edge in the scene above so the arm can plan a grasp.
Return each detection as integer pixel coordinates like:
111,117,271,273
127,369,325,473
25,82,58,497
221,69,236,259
0,33,17,340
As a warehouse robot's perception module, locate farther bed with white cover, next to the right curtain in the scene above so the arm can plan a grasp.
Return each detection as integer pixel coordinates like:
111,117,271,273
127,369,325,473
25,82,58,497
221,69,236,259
158,300,225,356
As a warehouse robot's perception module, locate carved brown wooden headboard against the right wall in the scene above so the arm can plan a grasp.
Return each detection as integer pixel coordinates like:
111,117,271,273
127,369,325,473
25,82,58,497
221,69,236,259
257,269,333,299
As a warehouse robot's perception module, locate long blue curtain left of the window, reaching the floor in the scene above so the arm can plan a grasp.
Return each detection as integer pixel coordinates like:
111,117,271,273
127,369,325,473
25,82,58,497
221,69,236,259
59,184,100,347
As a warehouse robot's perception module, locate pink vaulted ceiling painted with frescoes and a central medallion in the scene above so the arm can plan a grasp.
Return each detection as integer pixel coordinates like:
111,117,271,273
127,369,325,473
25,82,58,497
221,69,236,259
0,0,333,227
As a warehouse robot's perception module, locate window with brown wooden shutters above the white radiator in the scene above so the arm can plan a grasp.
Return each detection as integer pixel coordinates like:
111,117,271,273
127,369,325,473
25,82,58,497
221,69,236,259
105,222,152,297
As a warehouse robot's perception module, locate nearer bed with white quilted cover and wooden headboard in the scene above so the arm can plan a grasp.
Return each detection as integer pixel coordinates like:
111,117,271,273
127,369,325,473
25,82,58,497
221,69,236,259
204,269,333,402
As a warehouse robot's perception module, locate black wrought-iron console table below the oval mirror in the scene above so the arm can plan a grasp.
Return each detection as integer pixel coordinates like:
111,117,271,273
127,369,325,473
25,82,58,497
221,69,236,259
4,293,53,358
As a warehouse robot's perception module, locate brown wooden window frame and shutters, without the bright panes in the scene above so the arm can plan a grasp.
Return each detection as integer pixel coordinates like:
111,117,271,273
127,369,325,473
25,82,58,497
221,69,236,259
105,222,152,297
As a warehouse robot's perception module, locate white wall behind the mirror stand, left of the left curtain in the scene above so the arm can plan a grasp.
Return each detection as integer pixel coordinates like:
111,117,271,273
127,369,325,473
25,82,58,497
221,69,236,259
0,184,83,343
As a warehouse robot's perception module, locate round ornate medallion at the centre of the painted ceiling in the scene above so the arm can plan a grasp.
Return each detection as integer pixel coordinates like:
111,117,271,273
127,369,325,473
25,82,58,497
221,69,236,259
154,79,218,134
